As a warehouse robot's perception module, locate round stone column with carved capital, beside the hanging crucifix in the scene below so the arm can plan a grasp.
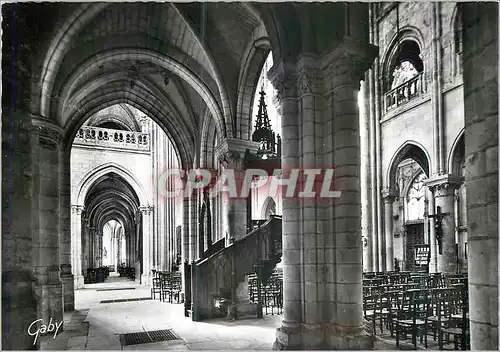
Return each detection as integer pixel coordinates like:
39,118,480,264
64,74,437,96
427,175,460,274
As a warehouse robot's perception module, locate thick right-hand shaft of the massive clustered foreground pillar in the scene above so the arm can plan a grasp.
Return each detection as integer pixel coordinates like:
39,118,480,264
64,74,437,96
318,48,375,350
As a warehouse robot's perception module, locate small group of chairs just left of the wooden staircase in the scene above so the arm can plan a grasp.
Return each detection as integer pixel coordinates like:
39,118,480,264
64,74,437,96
151,270,182,303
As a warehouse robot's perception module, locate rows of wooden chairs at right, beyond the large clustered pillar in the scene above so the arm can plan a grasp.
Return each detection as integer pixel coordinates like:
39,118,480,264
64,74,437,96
363,273,469,349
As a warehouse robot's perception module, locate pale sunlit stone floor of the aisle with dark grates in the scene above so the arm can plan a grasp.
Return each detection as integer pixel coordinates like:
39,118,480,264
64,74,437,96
41,276,281,350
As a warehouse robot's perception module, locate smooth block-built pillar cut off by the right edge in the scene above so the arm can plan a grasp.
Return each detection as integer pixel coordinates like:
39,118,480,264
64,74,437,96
458,2,499,351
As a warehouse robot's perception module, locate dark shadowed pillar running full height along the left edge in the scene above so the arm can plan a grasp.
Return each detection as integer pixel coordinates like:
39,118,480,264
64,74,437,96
2,9,40,350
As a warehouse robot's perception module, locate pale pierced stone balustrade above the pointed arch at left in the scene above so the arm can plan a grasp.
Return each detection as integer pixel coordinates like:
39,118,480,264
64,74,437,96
74,126,150,151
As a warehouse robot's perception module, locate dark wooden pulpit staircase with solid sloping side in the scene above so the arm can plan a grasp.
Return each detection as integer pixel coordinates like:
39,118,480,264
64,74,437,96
184,215,282,321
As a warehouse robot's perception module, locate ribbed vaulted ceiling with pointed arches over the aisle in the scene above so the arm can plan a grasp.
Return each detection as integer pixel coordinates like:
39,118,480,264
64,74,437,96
4,2,367,164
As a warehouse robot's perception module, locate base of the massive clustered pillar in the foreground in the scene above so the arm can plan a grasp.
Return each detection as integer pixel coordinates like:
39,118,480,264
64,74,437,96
273,324,373,350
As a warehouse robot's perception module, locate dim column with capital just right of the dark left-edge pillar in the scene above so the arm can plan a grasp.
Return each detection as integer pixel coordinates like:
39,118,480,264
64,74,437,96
33,118,64,332
